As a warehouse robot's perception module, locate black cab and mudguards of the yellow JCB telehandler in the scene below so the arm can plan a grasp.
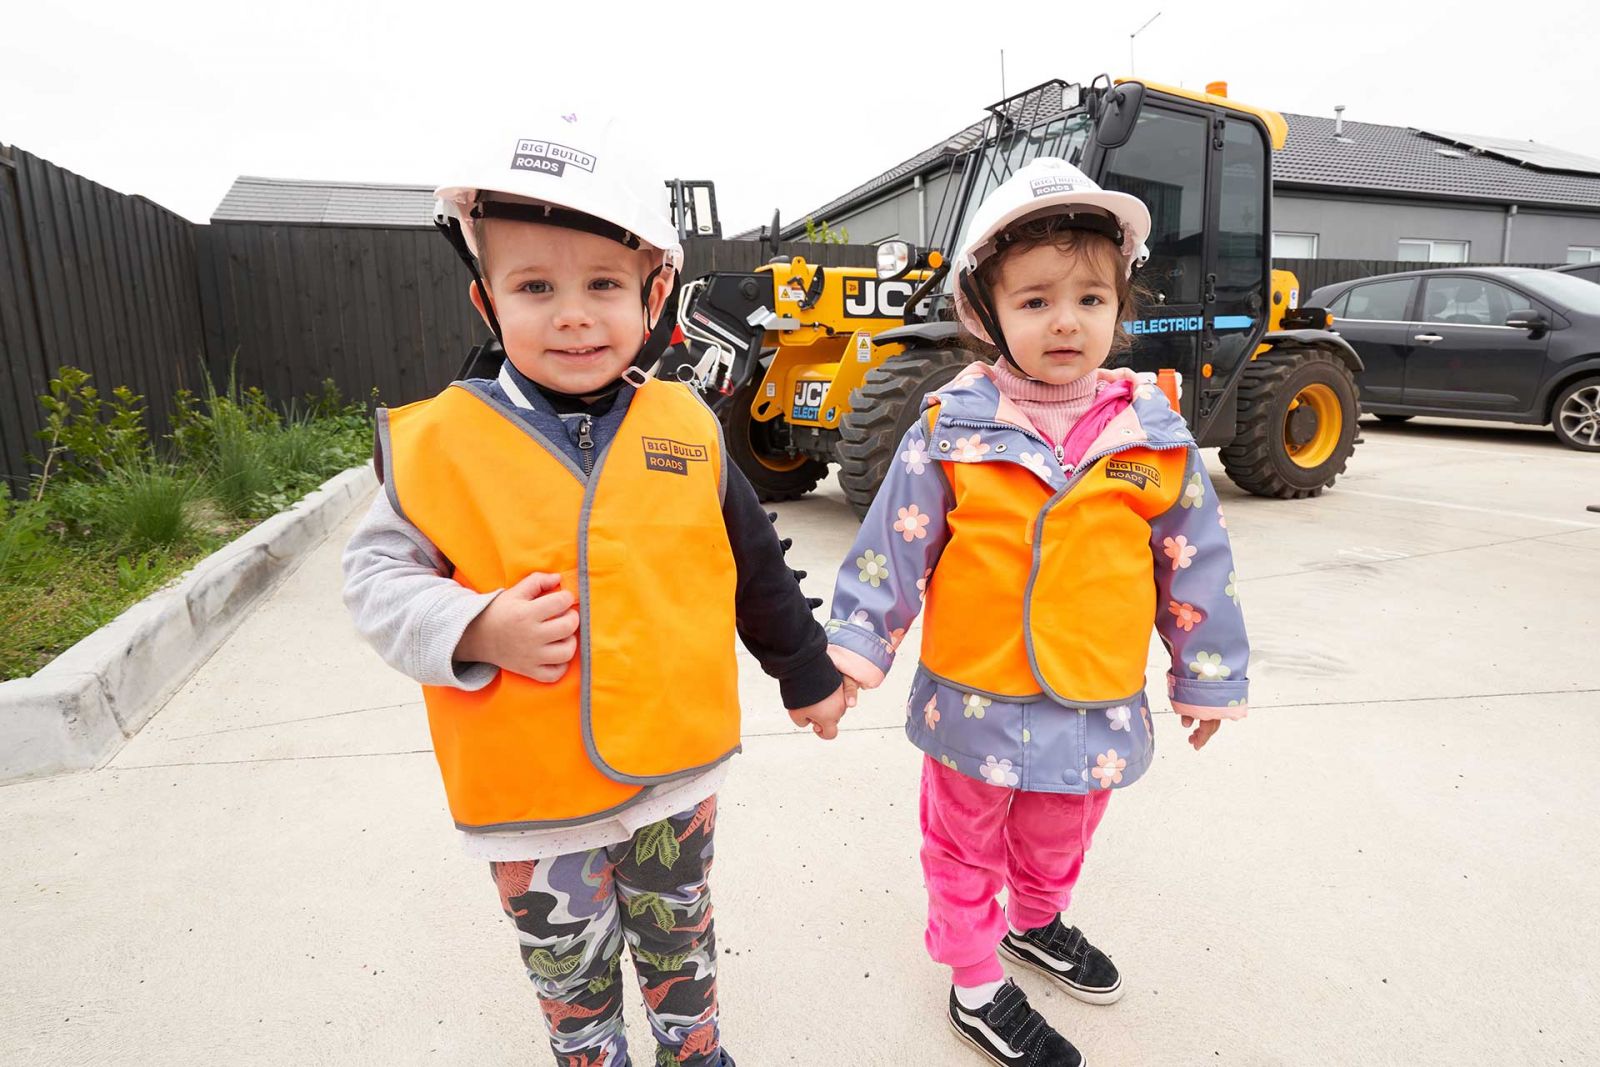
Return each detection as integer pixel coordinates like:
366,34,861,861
902,77,1360,445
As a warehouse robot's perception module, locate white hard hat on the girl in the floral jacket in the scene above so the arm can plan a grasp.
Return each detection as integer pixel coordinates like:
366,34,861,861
950,155,1150,341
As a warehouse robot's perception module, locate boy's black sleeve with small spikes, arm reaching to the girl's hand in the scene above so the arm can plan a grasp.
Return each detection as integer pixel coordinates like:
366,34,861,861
722,462,840,707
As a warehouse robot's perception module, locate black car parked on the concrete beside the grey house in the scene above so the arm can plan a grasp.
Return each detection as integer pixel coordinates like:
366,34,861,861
1306,267,1600,451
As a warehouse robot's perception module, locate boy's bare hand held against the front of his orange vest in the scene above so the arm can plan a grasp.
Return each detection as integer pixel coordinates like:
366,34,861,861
456,573,578,681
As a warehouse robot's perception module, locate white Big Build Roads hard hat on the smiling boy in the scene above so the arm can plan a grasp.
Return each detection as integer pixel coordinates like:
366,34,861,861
434,112,683,272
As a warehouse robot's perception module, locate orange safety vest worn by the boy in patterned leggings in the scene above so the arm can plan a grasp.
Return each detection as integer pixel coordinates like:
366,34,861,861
378,381,739,830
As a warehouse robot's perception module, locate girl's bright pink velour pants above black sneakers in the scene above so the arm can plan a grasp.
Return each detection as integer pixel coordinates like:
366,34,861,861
922,757,1110,985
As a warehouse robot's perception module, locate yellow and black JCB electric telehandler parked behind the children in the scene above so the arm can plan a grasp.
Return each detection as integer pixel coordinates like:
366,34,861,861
678,75,1362,514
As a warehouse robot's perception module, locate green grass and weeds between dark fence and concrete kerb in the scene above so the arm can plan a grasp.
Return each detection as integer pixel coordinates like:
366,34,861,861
0,368,373,680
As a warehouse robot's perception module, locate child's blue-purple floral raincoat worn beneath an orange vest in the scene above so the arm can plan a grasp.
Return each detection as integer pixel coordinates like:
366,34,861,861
827,365,1250,793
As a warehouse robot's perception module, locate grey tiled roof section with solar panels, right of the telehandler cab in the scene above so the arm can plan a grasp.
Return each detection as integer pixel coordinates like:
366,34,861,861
1272,115,1600,208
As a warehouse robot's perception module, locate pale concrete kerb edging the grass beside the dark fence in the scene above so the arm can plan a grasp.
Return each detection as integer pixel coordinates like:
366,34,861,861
0,464,376,782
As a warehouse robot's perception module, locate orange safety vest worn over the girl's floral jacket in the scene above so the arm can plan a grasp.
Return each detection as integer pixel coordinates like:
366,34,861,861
922,408,1187,705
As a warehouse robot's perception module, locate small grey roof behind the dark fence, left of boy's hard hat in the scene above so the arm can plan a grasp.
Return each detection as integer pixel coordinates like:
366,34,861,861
211,178,434,227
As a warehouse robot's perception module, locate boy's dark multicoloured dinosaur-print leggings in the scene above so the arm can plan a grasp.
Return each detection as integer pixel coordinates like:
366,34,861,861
490,797,722,1067
